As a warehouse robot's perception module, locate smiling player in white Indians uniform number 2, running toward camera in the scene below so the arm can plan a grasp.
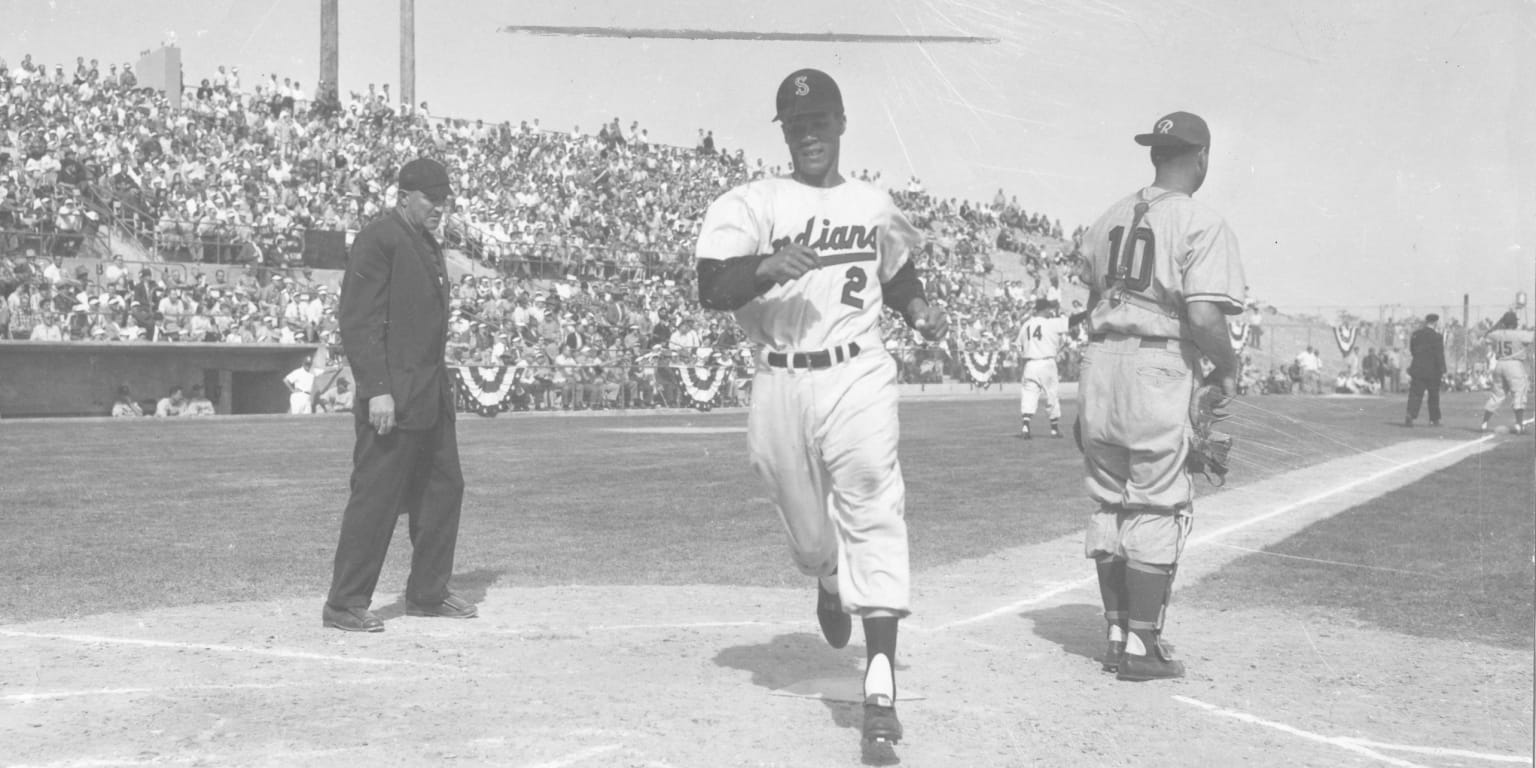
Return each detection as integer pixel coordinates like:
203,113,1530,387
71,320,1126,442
697,69,948,742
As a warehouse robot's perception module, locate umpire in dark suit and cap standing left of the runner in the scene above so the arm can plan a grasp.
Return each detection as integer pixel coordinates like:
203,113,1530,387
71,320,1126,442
323,158,476,631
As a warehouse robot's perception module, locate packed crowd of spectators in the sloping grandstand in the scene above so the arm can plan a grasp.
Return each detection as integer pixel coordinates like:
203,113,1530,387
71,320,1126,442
0,49,1511,407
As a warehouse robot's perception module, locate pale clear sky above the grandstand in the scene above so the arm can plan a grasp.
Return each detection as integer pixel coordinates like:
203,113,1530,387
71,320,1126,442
0,0,1536,318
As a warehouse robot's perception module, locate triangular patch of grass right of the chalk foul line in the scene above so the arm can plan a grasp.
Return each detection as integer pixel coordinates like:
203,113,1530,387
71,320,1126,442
1180,436,1536,648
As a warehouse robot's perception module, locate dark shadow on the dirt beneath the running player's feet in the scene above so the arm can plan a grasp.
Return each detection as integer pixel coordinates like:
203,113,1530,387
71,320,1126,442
714,633,903,765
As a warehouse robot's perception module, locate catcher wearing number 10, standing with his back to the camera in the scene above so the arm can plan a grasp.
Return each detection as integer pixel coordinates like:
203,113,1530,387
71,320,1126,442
1078,112,1246,680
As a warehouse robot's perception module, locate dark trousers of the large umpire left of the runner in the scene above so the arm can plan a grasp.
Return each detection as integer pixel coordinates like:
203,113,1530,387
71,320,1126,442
326,406,464,608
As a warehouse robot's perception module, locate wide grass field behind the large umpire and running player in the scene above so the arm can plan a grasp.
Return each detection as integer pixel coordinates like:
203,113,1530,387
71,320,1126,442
0,387,1511,622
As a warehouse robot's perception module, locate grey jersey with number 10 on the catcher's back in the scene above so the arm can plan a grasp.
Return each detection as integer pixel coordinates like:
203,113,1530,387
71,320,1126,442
1083,187,1247,339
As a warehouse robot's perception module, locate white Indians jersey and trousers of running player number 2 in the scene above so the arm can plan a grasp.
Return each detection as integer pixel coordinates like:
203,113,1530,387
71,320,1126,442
697,178,922,616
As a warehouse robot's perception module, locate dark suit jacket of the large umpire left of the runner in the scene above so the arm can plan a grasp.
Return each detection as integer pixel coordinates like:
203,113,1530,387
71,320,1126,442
338,210,453,430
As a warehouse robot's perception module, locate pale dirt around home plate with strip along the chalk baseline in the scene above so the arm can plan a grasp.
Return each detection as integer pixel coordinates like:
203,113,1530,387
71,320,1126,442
0,439,1533,768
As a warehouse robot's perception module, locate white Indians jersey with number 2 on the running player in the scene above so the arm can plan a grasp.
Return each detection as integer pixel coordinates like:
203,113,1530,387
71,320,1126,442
696,178,922,350
